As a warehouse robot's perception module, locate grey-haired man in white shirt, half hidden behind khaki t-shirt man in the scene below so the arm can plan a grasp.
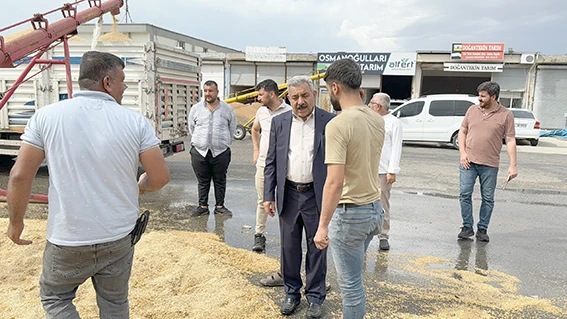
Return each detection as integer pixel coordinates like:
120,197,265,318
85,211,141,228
368,93,402,250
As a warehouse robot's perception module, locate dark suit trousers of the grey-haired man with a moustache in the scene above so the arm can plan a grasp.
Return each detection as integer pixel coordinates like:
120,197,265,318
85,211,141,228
279,182,327,304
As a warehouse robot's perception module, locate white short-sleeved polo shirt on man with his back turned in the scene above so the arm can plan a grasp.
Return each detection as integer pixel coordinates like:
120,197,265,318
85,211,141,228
22,91,160,246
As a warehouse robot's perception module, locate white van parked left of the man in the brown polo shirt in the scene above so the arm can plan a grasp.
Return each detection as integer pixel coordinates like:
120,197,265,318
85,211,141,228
392,94,478,149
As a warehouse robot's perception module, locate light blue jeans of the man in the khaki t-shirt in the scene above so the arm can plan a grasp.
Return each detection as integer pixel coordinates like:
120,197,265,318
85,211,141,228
329,201,384,319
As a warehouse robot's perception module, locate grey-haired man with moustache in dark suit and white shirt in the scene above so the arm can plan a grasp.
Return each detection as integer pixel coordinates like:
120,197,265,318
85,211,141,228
264,76,334,318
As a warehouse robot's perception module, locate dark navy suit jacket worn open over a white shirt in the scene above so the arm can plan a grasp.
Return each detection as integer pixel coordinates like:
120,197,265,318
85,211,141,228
264,107,335,213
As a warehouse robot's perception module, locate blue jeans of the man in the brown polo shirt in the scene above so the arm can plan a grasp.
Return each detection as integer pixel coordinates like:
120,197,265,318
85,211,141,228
459,163,498,230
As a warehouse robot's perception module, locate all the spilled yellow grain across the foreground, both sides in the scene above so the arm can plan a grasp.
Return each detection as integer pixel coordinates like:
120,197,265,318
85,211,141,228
0,218,567,319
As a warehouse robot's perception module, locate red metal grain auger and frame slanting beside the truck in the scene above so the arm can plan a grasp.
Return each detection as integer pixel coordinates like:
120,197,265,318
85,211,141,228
0,0,124,109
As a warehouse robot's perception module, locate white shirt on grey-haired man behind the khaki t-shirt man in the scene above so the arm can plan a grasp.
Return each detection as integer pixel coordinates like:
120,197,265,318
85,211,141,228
379,113,402,174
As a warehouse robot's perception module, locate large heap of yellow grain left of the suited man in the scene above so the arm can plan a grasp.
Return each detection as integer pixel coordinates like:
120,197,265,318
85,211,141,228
0,218,280,319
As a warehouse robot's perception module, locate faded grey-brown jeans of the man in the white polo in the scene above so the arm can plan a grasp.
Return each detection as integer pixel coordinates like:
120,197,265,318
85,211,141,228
39,235,134,319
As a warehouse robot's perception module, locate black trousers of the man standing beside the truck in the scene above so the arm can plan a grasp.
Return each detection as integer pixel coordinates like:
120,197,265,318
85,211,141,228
191,147,230,206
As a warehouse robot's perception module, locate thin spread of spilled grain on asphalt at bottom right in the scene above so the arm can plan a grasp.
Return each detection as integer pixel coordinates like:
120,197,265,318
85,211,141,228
367,253,567,319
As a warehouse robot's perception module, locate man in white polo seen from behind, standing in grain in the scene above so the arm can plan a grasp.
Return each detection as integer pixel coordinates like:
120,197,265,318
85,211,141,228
7,51,169,318
